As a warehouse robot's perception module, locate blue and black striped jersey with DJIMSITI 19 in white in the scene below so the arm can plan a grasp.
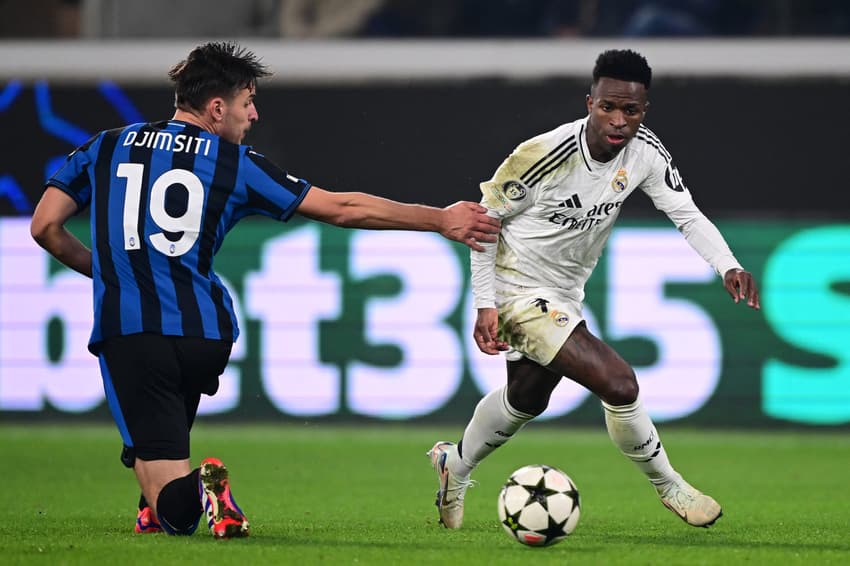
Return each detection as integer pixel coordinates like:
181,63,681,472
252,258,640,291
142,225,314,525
47,120,310,353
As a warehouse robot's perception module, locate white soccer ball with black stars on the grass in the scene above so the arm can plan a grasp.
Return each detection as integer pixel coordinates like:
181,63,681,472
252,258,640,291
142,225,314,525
499,464,581,546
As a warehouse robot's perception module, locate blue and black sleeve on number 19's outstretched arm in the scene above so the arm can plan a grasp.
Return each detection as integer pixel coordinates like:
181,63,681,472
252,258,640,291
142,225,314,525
243,149,312,222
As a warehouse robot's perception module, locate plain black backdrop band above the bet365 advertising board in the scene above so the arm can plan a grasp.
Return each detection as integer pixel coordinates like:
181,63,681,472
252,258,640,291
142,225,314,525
0,77,850,221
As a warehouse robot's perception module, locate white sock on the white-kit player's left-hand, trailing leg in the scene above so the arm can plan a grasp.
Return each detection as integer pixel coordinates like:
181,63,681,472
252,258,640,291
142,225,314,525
447,385,534,478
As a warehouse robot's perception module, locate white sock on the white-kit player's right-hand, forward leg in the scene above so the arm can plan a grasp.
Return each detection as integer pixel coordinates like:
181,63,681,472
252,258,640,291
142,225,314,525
602,398,679,490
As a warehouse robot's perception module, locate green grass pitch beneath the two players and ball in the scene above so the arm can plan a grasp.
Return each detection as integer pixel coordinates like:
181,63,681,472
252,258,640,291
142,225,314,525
0,423,850,566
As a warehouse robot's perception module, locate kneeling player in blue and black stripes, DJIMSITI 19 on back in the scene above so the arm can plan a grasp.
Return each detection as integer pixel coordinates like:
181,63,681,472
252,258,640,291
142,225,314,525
32,43,498,538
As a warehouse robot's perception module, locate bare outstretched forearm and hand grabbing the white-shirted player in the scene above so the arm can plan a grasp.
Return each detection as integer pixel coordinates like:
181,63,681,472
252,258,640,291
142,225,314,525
298,186,499,251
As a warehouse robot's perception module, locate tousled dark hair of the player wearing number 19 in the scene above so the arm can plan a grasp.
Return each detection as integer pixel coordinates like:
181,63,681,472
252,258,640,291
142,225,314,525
168,42,271,110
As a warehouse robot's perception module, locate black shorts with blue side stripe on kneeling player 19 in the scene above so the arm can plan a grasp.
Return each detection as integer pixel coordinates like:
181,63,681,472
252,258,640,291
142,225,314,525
99,333,233,467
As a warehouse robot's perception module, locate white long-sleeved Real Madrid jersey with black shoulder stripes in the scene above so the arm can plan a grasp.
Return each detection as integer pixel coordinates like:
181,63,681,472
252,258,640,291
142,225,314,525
472,118,740,308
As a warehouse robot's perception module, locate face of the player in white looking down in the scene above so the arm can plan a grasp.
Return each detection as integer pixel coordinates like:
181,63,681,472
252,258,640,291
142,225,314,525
587,77,649,162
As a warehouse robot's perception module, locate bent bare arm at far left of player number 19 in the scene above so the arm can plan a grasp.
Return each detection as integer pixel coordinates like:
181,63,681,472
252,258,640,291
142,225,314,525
30,186,91,277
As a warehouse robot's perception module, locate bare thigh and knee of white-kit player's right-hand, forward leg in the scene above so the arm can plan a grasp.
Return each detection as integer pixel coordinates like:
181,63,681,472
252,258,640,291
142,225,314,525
547,322,637,405
